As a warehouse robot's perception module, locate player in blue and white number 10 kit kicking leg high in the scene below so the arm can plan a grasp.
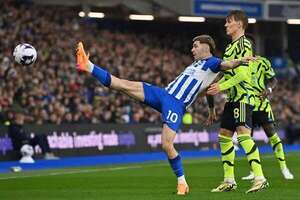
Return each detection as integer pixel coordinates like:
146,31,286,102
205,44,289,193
76,35,253,195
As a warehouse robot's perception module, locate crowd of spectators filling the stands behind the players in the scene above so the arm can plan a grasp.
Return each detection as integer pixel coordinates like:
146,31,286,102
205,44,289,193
0,1,300,128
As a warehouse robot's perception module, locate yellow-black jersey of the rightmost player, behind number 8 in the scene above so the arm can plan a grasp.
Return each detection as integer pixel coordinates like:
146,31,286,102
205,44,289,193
249,56,275,112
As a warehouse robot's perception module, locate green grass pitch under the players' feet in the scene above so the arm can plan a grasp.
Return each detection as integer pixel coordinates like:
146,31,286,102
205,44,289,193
0,153,300,200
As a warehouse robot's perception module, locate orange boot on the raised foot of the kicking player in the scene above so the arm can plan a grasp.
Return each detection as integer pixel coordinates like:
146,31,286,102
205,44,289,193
76,42,90,72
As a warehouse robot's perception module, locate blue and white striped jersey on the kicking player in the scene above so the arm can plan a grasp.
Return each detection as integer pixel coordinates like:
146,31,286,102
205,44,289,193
165,56,222,107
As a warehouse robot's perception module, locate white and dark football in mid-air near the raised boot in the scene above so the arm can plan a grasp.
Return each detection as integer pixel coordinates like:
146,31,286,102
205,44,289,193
13,43,37,65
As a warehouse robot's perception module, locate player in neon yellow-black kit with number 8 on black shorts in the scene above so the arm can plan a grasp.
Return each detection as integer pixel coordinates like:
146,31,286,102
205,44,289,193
207,10,268,193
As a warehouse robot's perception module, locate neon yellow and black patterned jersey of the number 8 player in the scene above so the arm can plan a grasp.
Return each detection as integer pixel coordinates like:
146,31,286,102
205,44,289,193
222,36,254,105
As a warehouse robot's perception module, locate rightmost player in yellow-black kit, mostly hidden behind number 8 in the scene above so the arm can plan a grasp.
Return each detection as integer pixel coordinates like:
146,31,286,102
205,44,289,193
242,35,294,180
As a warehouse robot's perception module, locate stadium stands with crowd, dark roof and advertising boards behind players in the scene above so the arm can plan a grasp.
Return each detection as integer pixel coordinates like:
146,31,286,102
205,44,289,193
0,0,300,166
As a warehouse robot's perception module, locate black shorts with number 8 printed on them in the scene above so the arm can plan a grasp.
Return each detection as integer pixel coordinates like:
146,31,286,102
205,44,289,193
221,102,253,132
